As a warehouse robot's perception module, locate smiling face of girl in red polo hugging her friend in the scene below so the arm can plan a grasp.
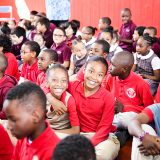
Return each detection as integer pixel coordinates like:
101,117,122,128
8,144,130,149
84,61,107,94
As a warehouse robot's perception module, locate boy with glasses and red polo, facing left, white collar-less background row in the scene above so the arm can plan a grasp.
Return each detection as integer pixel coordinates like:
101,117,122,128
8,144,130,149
19,41,41,84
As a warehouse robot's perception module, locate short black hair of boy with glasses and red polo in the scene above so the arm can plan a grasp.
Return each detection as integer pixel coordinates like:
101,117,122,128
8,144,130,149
23,41,40,57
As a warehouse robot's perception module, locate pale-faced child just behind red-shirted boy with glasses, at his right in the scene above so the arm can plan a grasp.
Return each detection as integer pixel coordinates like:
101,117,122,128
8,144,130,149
34,33,47,51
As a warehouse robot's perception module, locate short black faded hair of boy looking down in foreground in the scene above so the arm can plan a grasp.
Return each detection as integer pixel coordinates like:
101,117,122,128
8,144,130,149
6,81,46,115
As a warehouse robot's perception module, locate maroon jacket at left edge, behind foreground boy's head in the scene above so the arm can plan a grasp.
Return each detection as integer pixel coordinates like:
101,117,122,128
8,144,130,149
0,74,17,119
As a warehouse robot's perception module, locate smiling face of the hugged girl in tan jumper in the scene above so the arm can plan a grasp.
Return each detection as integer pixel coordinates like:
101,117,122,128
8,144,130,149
46,68,68,100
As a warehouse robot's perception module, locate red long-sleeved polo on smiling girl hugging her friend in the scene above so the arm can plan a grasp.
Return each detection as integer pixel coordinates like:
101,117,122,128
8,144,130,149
68,81,115,146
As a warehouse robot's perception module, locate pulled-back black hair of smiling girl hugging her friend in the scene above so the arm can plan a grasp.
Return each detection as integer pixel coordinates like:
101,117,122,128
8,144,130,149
85,55,108,75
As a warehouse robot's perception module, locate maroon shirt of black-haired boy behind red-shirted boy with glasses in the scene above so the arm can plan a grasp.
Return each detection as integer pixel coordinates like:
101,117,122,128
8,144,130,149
11,38,29,60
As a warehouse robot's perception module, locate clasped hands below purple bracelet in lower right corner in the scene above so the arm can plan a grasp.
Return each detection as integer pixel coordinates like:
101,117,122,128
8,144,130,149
138,134,160,156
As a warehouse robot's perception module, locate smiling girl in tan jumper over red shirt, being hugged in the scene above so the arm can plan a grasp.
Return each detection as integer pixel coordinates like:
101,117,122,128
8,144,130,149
46,64,80,138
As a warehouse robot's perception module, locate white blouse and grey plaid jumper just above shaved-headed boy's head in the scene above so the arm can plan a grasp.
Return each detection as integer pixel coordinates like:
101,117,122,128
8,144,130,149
107,43,123,63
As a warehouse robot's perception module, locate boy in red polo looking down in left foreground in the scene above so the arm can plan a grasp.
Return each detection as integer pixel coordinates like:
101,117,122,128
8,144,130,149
4,82,60,160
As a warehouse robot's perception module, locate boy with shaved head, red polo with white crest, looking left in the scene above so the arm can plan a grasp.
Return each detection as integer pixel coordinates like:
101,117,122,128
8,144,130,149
103,51,154,129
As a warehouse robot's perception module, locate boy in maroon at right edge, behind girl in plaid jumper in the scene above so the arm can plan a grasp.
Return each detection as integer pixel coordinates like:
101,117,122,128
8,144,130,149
143,27,160,58
